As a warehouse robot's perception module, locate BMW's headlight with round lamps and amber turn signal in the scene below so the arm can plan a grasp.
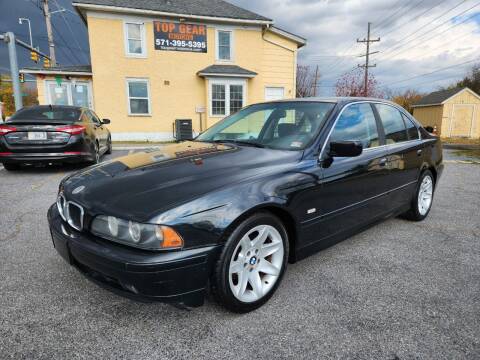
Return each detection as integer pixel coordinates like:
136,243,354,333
91,215,183,250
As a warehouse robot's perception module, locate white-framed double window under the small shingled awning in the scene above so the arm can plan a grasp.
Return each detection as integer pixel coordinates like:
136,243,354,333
210,80,246,116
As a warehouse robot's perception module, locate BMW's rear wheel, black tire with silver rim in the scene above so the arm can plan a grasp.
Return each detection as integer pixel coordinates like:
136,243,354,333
402,170,435,221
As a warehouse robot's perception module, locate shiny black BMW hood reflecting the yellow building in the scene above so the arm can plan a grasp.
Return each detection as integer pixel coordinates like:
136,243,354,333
61,141,302,222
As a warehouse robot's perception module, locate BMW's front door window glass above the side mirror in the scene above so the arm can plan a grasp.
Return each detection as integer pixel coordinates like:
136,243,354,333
330,103,380,149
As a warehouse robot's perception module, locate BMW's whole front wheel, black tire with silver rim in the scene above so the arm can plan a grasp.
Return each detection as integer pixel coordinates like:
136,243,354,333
211,212,289,313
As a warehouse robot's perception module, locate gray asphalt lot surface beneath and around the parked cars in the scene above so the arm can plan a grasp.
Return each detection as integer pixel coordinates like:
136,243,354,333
0,153,480,359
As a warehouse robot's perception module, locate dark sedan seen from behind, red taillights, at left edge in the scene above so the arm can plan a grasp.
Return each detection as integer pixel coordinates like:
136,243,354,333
0,105,112,170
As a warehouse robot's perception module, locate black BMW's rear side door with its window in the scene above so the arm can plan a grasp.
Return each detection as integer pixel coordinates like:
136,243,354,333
374,104,423,208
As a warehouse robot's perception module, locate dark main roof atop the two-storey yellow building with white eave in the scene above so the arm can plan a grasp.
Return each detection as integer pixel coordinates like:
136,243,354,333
73,0,272,23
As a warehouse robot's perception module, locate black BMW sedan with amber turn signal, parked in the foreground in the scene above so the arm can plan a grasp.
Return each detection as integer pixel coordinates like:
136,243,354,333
48,98,443,312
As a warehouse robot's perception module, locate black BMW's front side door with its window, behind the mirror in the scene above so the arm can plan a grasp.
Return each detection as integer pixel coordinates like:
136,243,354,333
304,102,388,248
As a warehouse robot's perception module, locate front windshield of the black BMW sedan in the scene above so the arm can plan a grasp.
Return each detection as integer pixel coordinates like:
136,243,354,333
196,101,335,150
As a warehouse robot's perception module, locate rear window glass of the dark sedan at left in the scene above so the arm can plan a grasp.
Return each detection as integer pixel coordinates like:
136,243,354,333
8,106,81,122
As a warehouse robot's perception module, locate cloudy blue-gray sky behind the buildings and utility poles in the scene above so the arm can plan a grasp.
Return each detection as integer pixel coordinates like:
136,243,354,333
0,0,480,95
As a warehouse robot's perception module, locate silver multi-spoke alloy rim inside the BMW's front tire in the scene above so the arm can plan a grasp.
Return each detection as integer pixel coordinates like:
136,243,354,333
228,225,285,303
